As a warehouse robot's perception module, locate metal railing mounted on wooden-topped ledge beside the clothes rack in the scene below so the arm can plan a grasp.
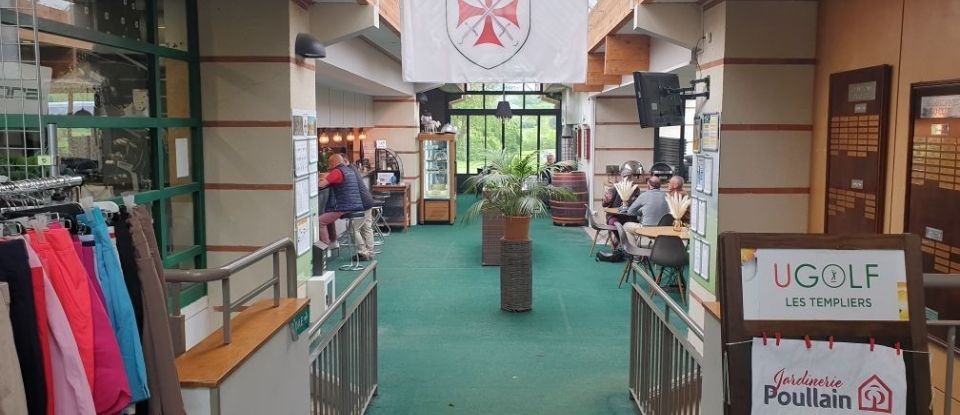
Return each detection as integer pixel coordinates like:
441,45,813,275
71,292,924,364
163,238,297,344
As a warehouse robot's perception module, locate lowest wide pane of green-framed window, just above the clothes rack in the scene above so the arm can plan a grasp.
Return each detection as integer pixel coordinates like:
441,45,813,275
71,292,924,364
57,128,154,200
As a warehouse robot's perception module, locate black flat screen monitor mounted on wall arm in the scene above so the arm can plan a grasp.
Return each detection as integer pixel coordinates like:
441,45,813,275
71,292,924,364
633,72,683,128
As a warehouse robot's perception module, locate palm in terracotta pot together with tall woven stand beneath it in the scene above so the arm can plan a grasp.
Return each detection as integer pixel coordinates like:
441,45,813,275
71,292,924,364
464,152,574,311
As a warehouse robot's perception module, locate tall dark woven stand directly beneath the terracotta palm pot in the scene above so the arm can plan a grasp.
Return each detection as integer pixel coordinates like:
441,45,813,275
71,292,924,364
500,240,533,312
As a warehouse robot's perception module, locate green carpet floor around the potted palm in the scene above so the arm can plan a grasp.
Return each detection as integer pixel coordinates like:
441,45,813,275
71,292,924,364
331,199,648,415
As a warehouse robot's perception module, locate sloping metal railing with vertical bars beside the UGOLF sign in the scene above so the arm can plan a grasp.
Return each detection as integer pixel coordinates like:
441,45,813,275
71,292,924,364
630,265,703,415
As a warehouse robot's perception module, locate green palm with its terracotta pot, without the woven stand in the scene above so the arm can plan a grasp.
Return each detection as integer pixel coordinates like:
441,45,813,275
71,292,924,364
464,152,574,241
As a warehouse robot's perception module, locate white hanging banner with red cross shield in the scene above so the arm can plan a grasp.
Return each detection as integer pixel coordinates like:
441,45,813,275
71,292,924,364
402,0,589,83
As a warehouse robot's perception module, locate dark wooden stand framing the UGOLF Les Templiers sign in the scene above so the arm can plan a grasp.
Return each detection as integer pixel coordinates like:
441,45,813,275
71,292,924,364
719,233,931,415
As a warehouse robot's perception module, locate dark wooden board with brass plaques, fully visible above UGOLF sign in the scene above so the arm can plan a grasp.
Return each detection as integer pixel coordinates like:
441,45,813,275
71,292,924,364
824,65,891,234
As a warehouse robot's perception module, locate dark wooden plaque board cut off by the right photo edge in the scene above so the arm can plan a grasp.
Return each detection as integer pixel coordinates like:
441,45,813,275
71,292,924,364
905,80,960,338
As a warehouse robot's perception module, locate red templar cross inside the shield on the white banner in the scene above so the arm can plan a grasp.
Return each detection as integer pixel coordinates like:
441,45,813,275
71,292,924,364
457,0,520,47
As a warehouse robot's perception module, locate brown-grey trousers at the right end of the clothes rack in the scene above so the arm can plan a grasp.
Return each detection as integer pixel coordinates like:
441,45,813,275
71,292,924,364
130,206,187,415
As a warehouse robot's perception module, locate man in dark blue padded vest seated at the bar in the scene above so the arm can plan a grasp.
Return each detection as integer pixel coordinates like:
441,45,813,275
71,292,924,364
317,154,370,246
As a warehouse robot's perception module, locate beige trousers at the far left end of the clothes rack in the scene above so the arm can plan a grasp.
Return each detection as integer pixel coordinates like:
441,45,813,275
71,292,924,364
0,282,27,414
